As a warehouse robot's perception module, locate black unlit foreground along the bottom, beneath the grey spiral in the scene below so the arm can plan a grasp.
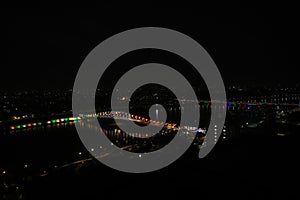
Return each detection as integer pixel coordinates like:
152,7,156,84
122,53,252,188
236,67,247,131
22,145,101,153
24,134,300,199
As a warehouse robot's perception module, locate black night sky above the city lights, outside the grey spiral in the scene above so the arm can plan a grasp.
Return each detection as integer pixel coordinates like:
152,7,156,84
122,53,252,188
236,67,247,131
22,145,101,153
0,6,299,90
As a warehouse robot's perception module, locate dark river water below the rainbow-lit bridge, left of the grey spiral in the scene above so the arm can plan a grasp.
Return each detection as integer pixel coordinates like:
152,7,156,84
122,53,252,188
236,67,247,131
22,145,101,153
0,124,82,167
